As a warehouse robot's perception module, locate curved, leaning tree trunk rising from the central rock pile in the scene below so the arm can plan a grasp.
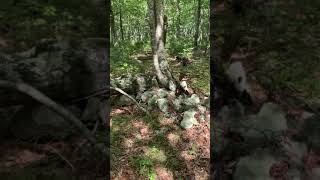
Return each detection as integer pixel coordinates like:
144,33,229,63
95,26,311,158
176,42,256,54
148,0,177,90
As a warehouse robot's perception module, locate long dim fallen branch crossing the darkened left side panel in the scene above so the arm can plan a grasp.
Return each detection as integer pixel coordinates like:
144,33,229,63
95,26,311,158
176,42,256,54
0,80,107,155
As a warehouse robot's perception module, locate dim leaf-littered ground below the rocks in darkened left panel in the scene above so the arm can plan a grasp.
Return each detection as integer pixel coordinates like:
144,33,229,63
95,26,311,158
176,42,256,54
0,36,109,180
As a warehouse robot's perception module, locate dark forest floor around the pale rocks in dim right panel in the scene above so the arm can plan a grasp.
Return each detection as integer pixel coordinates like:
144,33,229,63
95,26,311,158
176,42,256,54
213,1,320,179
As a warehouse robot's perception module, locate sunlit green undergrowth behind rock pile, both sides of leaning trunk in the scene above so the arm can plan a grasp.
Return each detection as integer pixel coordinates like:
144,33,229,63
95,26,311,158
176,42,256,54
111,44,210,93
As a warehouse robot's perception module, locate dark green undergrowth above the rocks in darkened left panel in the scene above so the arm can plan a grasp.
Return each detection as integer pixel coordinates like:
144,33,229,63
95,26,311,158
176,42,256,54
0,0,106,48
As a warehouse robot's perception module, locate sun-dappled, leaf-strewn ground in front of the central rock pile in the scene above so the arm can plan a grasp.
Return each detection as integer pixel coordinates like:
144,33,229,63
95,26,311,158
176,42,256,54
111,108,210,180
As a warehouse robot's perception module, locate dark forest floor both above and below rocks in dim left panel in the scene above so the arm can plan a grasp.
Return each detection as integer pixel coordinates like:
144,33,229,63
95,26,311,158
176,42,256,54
0,0,109,180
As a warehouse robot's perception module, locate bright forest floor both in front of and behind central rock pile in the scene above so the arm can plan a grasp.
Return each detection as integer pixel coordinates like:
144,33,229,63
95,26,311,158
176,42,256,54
110,53,210,180
